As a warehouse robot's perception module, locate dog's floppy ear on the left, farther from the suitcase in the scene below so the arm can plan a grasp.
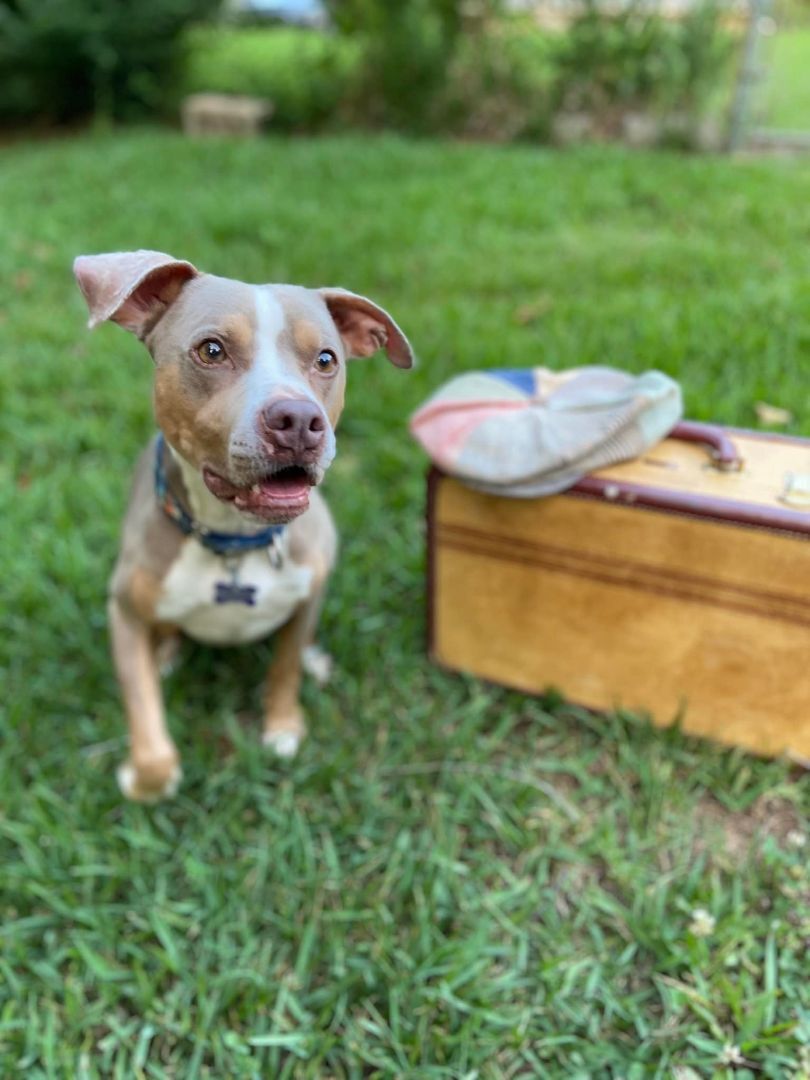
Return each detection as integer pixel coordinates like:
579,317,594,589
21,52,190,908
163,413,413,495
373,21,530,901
73,251,199,338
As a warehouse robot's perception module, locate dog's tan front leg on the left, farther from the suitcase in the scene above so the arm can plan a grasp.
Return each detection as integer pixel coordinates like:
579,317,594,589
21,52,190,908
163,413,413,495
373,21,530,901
108,597,181,802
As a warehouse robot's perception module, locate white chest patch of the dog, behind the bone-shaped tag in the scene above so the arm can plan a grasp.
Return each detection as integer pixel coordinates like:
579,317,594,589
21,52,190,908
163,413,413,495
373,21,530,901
157,537,312,645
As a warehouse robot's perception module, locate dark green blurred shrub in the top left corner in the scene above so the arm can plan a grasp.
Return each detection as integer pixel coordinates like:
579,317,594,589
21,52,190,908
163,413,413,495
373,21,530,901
0,0,218,123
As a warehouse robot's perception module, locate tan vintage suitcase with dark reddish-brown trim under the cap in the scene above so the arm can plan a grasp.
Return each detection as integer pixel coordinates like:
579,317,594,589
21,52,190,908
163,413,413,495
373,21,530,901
428,423,810,764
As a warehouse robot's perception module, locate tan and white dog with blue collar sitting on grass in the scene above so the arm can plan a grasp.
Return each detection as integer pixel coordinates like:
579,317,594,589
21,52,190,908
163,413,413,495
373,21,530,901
73,251,414,800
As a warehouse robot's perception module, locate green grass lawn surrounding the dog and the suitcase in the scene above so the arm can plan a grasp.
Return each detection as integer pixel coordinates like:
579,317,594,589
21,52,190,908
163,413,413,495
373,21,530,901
0,132,810,1080
